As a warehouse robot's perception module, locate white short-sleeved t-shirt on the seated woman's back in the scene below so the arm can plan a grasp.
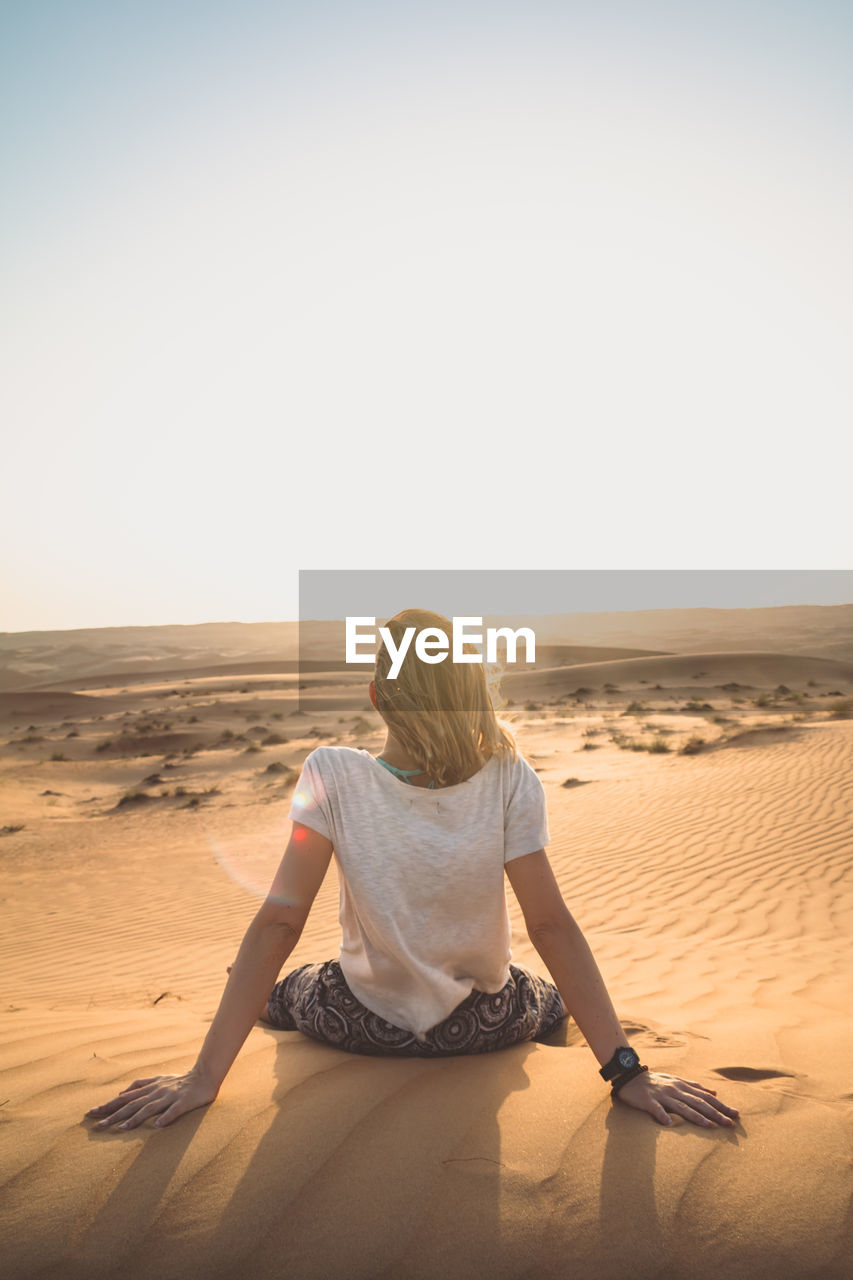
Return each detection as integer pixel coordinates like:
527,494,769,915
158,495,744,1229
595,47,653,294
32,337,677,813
291,746,548,1036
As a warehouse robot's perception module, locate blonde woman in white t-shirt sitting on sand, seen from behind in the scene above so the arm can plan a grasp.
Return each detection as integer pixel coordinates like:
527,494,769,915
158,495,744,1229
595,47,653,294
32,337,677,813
90,609,738,1129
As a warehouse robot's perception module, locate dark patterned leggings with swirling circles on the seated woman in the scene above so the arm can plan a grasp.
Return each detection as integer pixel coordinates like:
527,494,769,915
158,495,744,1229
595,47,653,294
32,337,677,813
265,960,566,1057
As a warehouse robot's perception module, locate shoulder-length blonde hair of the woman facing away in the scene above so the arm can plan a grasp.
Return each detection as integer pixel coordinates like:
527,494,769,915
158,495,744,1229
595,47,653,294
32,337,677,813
374,609,516,787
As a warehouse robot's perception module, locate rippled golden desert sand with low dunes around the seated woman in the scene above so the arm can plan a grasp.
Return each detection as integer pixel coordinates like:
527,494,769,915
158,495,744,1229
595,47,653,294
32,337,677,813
0,632,853,1280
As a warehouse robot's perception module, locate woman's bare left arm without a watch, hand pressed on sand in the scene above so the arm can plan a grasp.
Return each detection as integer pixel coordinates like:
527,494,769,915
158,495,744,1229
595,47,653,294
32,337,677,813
88,823,332,1129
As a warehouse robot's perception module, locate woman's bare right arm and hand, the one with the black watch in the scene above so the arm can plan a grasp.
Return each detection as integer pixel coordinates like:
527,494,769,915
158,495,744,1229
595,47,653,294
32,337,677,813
505,849,738,1125
